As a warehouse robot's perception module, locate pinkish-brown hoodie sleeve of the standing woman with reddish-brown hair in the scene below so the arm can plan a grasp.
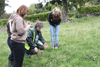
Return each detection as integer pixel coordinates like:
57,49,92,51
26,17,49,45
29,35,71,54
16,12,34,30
15,18,27,36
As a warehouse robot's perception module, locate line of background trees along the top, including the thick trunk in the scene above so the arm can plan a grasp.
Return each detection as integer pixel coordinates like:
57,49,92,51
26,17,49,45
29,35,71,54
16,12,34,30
0,0,100,22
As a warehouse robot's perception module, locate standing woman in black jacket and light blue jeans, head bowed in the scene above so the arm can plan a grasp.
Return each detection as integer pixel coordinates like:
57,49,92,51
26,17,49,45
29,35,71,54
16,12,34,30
48,7,61,48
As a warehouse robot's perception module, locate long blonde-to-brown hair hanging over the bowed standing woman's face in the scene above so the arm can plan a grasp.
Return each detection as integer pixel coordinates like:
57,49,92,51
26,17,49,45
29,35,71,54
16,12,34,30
52,7,62,20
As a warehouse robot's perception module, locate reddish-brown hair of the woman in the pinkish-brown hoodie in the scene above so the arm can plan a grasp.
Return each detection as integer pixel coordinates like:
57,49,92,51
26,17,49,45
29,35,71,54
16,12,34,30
16,5,29,18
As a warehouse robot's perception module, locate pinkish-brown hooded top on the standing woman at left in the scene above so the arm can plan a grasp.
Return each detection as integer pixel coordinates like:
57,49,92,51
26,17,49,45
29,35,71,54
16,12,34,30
7,13,27,43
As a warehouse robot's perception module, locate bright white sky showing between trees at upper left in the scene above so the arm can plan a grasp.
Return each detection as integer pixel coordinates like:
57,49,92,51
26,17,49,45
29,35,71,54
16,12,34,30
5,0,46,13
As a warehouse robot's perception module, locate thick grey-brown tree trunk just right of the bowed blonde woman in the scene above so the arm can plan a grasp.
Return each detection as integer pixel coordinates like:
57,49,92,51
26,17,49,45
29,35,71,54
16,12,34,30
62,0,68,22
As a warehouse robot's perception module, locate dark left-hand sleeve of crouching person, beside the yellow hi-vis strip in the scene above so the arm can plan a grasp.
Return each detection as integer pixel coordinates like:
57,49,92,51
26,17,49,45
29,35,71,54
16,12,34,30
26,30,37,48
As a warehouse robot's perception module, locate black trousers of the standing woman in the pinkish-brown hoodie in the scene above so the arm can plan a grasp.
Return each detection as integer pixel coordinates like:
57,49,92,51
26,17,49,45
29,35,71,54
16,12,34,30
10,40,25,67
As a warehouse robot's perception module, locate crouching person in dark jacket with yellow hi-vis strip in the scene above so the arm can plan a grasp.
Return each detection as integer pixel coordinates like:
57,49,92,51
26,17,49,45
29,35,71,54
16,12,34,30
25,21,48,58
